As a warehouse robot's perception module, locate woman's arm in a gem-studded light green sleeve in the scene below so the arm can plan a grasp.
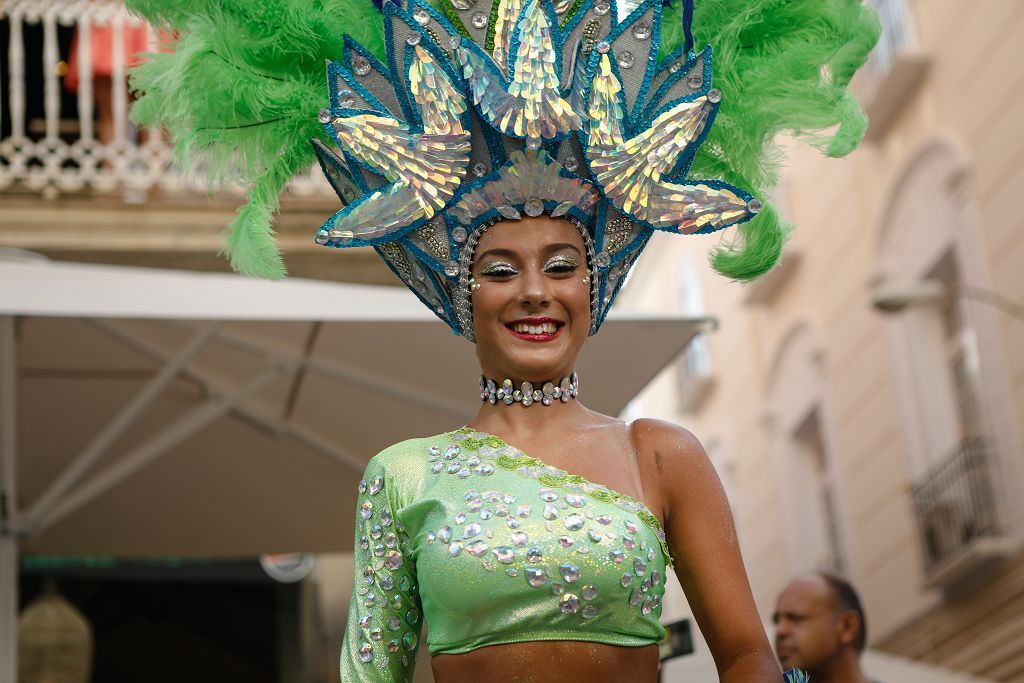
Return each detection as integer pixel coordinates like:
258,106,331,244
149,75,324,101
341,456,423,683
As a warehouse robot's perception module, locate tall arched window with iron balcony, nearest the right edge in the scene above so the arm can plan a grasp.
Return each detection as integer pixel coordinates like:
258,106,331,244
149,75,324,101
876,141,1024,585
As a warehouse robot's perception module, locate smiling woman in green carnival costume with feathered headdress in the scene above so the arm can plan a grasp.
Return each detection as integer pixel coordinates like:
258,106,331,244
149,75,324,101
129,0,879,683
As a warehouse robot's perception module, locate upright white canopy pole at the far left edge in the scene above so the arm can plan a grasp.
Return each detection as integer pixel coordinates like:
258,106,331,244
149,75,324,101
0,315,19,683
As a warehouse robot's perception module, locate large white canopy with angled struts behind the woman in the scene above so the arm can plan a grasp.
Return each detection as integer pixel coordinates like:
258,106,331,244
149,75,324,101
0,260,708,679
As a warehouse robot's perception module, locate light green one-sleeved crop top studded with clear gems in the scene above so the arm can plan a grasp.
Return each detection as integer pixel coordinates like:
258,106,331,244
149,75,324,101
341,428,672,682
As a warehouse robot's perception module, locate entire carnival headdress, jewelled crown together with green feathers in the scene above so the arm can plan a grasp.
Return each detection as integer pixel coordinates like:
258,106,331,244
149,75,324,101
129,0,878,339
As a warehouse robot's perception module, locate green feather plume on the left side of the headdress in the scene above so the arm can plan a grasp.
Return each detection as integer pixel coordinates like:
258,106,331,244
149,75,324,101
128,0,384,279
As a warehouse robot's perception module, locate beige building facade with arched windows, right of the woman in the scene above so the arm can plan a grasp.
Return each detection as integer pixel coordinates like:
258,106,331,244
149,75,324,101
622,0,1024,681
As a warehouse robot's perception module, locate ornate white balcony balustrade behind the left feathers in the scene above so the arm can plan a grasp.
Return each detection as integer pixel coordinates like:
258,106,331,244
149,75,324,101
0,0,333,201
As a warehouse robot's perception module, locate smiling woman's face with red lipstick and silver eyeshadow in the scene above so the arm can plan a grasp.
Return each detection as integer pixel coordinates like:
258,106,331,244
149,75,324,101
472,216,590,382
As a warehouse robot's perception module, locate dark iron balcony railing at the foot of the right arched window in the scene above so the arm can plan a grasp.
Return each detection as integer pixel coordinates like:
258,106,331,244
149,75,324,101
913,437,999,574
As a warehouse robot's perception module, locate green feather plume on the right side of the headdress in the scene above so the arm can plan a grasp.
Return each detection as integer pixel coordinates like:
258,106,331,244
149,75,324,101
660,0,881,281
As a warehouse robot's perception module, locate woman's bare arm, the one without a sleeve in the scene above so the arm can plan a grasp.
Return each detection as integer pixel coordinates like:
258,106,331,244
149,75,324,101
634,420,782,683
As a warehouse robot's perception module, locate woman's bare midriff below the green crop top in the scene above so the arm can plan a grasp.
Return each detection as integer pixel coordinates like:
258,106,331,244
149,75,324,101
430,640,658,683
